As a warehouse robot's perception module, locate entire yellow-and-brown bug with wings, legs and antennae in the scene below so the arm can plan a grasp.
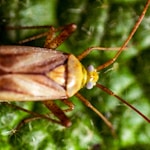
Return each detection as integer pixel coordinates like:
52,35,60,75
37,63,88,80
0,0,150,134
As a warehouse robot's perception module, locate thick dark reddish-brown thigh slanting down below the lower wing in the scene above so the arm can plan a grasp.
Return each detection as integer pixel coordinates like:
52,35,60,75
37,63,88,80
43,100,71,127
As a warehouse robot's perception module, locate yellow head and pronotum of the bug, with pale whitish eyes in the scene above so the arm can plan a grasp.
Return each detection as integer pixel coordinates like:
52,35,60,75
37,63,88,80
67,55,99,96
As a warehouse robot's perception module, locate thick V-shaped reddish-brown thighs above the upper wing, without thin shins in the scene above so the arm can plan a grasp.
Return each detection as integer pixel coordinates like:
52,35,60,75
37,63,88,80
44,24,77,49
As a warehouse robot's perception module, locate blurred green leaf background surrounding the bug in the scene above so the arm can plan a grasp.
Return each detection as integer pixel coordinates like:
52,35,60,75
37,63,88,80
0,0,150,150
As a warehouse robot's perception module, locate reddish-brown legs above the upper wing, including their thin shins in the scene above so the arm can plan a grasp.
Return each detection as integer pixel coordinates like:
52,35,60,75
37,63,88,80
5,24,77,45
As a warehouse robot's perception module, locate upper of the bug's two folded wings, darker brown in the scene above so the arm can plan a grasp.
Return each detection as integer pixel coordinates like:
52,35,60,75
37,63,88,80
0,46,67,73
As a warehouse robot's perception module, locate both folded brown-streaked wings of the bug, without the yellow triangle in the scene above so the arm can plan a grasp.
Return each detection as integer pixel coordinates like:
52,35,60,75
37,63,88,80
0,46,68,101
